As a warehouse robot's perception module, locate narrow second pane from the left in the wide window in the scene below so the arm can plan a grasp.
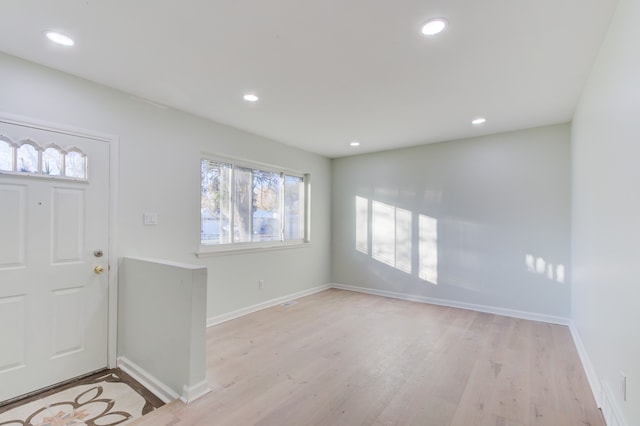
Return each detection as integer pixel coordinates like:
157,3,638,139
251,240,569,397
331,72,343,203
233,167,253,243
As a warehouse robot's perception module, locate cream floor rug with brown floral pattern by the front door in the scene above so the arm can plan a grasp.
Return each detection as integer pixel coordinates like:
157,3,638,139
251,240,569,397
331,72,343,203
0,370,162,426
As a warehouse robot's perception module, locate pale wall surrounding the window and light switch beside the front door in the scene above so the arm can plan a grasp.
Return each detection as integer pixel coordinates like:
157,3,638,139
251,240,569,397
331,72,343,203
0,53,331,317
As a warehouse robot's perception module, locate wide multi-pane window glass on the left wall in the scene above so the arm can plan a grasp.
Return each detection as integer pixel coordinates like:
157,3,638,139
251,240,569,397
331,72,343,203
200,158,308,248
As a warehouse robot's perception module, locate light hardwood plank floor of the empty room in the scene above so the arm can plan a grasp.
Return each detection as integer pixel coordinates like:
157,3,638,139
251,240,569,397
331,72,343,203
134,289,604,426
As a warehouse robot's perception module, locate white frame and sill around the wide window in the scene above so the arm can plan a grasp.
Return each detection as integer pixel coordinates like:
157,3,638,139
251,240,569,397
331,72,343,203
196,153,311,257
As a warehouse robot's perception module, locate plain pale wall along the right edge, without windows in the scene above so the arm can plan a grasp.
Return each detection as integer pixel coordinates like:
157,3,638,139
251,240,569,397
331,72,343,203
572,0,640,425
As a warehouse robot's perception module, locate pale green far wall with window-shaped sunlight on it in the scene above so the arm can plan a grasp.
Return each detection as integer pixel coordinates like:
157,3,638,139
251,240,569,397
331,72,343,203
332,124,570,318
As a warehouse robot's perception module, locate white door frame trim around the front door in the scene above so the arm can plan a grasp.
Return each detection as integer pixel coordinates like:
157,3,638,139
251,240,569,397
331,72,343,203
0,112,120,370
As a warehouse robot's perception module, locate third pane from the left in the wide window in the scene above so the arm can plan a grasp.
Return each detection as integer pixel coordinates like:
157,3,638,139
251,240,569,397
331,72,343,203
253,170,282,241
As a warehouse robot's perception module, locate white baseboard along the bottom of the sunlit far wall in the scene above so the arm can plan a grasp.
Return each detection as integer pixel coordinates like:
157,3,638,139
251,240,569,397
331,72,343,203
331,283,571,325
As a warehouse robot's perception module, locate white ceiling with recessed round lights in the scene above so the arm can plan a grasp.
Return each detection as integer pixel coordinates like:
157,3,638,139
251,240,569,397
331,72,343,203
0,0,617,157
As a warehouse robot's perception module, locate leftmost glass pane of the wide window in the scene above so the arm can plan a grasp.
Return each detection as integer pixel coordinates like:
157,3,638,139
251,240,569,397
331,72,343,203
200,160,232,244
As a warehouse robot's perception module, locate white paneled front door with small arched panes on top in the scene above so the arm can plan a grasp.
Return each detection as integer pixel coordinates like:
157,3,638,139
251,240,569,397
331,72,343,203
0,120,109,401
